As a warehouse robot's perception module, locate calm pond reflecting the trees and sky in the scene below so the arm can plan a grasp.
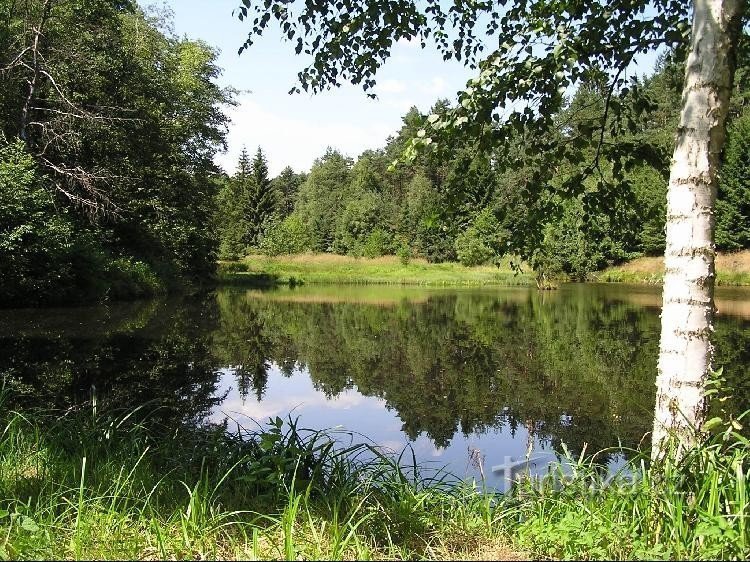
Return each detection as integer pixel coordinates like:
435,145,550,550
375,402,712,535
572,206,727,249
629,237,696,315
0,284,750,488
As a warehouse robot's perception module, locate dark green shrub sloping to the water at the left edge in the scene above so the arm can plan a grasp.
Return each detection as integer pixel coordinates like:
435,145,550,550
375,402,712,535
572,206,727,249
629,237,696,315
0,141,163,306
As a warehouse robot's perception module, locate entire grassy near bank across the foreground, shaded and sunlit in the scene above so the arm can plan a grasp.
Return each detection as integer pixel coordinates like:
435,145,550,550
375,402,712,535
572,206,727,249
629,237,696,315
0,382,750,559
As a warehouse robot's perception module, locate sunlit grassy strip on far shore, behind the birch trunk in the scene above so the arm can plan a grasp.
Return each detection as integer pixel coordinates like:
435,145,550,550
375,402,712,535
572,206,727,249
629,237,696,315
596,250,750,285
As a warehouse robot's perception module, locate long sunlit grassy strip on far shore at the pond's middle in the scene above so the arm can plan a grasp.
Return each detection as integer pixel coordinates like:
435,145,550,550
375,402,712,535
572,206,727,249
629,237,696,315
219,254,533,286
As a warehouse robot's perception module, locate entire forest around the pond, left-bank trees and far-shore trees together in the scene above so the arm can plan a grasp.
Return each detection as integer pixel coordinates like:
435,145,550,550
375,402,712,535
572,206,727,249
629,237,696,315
0,0,750,304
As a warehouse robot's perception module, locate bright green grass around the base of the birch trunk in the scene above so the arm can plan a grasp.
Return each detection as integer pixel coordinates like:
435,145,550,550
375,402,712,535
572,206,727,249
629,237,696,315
501,406,750,560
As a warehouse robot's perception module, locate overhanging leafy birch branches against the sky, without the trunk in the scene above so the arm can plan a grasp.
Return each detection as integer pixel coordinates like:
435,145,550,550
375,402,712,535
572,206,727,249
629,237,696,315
236,0,690,190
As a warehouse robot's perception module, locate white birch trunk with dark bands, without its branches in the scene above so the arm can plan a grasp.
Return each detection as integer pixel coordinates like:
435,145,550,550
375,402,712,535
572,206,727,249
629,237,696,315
652,0,744,458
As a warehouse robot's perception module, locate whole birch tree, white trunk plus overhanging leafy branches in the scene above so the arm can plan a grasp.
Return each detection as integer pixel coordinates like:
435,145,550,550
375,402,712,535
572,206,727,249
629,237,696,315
238,0,744,455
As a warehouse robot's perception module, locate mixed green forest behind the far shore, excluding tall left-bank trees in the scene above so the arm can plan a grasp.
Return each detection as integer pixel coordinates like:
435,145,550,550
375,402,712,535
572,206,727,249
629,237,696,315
218,55,750,281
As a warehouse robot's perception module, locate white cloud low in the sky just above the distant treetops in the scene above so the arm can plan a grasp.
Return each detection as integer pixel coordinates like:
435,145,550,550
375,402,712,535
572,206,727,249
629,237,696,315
216,95,397,177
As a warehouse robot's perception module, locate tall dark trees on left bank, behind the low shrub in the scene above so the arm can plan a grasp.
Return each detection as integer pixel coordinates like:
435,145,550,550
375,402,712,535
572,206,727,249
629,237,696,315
0,0,231,302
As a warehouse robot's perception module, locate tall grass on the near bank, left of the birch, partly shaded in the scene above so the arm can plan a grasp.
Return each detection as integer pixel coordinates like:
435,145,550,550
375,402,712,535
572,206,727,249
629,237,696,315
0,388,510,559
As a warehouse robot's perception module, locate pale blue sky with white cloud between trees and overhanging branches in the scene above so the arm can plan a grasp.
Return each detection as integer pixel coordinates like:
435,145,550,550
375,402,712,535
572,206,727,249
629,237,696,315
139,0,655,176
